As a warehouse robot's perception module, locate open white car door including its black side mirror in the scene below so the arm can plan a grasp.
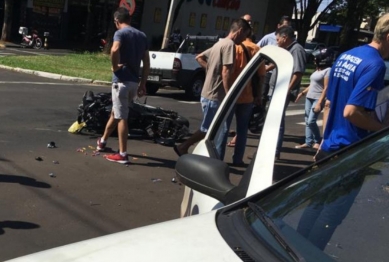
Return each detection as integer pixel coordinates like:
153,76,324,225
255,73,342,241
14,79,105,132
176,46,293,217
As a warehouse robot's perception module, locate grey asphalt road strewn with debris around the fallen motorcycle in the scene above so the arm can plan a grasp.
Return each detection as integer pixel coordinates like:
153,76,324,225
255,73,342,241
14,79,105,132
0,67,314,261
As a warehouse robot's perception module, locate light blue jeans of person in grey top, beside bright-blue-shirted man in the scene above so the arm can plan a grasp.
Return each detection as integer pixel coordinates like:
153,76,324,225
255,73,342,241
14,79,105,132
305,97,321,146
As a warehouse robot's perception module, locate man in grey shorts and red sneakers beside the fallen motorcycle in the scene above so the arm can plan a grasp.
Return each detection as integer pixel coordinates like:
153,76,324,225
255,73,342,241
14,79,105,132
97,7,150,164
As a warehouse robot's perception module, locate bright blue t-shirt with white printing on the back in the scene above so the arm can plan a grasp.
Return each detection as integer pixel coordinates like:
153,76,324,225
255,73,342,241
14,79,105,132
321,45,386,152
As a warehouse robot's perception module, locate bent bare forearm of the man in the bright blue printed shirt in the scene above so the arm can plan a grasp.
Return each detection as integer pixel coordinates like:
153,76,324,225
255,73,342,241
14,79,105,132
343,105,388,131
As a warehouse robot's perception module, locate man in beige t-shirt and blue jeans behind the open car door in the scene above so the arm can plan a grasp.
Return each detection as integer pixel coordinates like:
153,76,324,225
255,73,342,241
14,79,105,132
174,18,251,159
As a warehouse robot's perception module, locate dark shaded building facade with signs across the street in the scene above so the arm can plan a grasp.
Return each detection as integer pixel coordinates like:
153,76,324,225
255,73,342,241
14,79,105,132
0,0,293,49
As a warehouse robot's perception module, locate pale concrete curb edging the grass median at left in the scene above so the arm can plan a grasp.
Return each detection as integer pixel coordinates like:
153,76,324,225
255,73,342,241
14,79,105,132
0,63,112,86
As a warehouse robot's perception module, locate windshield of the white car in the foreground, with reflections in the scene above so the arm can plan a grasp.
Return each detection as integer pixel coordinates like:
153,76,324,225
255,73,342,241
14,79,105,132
245,130,389,261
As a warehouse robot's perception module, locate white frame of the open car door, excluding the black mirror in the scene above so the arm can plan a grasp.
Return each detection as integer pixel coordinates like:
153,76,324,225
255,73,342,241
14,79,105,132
181,46,293,216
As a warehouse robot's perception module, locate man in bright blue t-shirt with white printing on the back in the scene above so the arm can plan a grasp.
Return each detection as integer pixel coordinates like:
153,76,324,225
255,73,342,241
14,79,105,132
315,14,389,161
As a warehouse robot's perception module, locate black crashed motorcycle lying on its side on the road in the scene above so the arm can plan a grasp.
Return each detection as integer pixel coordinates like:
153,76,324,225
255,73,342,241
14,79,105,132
69,91,189,146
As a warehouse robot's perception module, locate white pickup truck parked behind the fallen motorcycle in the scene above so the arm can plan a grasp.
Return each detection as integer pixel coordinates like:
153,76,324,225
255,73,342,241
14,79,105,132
146,35,219,99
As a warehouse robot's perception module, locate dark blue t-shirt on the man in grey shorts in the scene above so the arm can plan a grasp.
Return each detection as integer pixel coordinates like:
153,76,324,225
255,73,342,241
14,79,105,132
112,26,148,83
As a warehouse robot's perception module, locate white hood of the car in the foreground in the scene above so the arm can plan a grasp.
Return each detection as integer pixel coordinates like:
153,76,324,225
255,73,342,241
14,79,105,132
9,211,241,262
